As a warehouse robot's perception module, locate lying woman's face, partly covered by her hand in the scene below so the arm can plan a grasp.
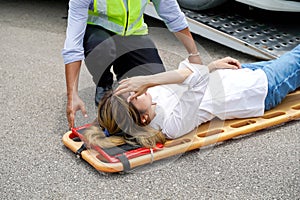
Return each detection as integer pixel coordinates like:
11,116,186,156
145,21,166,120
130,92,156,120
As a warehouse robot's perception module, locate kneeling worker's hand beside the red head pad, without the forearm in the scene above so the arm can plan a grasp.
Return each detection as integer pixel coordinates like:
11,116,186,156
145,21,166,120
66,95,87,129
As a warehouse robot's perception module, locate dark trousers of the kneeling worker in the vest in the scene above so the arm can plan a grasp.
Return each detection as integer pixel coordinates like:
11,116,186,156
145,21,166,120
83,25,165,87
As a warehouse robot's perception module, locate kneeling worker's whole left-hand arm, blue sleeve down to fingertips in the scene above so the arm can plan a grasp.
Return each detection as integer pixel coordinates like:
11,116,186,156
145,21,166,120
62,0,90,128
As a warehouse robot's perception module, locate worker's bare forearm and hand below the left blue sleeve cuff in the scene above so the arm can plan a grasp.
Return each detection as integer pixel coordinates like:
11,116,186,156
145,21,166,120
65,61,87,128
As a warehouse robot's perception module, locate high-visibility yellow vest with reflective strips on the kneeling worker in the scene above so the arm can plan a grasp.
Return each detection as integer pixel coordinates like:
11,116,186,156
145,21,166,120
88,0,149,36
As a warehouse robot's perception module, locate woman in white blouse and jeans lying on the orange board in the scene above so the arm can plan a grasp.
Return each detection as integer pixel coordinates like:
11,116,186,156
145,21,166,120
84,45,300,148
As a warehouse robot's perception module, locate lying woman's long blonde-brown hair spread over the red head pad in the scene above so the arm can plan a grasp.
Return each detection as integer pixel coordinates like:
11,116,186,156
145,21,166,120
83,91,166,148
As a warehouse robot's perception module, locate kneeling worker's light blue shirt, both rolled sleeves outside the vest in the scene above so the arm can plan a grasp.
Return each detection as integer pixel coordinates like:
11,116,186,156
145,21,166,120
62,0,188,64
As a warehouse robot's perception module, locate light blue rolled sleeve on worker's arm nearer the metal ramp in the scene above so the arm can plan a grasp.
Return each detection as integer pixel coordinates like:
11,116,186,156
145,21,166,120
152,0,188,32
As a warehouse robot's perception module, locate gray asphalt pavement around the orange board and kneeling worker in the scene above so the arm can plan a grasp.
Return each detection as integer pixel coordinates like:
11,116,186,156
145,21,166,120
0,0,300,200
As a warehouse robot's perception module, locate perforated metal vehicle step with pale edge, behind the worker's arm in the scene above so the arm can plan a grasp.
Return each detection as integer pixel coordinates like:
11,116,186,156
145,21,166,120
145,3,300,60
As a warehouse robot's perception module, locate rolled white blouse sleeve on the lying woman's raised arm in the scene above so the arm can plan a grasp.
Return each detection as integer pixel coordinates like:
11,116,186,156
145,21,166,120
162,60,209,139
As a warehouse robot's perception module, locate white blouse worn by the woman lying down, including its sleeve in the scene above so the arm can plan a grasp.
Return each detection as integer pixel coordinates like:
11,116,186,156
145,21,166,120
148,60,268,139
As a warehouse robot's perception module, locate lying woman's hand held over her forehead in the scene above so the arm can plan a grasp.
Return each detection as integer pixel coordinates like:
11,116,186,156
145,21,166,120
114,76,149,100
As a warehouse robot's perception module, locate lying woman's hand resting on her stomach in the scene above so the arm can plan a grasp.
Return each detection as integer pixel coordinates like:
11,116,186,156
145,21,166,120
208,57,241,71
